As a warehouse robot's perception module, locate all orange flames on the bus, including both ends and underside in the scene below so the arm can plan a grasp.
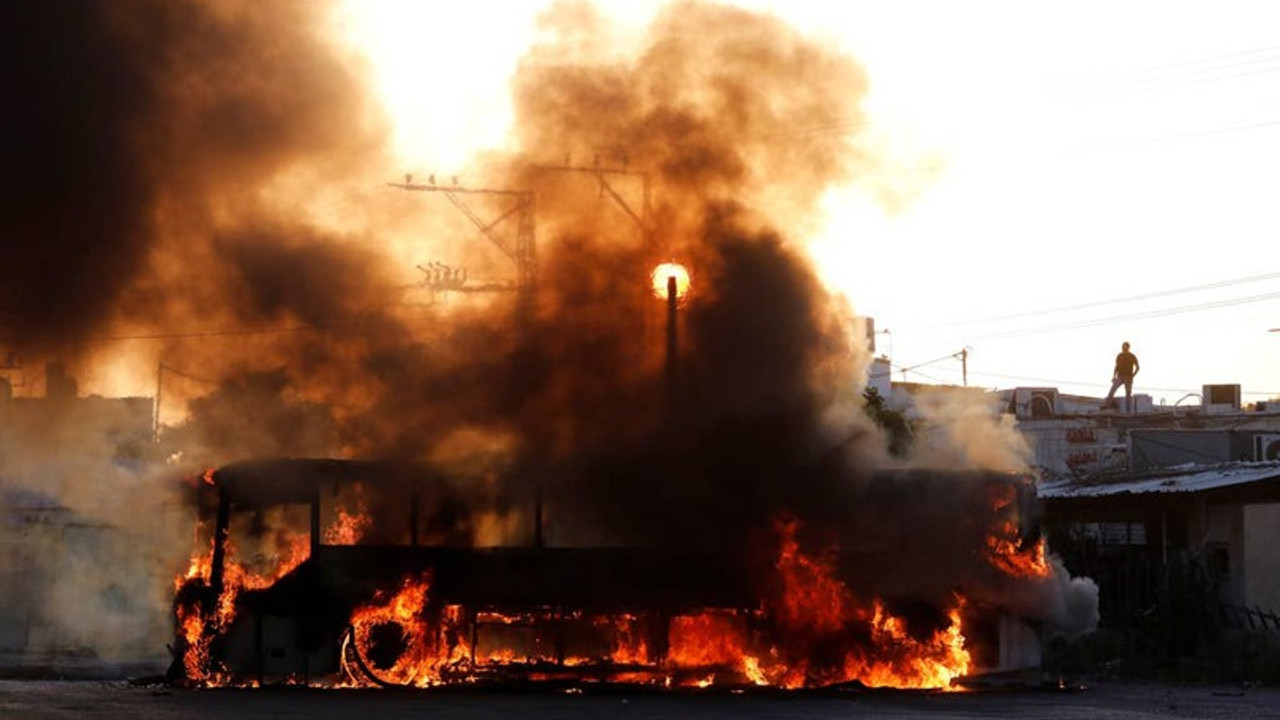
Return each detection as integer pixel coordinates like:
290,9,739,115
175,458,977,689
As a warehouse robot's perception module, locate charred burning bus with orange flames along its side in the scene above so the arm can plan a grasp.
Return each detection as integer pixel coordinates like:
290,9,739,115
170,459,1051,689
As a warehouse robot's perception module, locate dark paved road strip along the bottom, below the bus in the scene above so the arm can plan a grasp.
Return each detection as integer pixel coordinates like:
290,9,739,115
0,680,1280,720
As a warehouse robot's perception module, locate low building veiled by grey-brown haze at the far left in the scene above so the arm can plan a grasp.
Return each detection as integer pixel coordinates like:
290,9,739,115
0,364,165,671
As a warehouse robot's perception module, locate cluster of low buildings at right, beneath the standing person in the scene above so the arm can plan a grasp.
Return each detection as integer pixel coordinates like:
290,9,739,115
869,359,1280,624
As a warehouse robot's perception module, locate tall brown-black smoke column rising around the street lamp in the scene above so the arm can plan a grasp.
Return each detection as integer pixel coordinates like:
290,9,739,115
504,3,885,544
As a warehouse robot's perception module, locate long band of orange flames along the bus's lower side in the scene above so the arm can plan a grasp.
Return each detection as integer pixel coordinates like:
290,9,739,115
327,519,970,689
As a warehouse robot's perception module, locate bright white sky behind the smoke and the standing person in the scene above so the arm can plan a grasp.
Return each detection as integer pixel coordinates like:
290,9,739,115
340,0,1280,405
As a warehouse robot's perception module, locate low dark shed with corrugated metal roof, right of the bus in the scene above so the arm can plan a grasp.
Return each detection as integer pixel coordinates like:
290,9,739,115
1039,461,1280,619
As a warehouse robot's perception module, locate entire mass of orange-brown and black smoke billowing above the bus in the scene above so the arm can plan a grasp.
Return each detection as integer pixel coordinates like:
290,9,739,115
0,0,1100,666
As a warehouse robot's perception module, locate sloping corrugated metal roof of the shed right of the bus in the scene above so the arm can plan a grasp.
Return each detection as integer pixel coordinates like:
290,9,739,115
1037,462,1280,498
